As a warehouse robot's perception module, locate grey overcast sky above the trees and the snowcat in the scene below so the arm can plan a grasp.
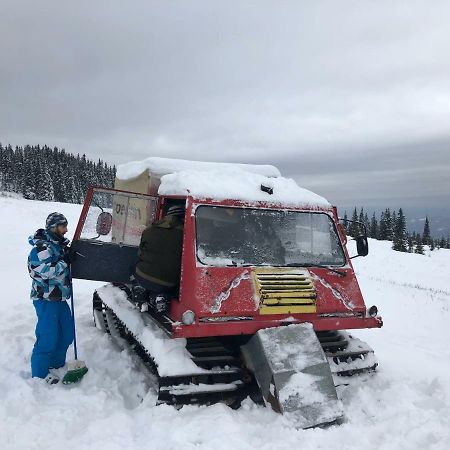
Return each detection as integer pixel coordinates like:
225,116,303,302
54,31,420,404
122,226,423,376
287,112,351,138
0,0,450,208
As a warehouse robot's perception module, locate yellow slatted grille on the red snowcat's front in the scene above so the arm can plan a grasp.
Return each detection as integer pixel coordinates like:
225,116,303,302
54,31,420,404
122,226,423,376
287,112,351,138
253,268,316,314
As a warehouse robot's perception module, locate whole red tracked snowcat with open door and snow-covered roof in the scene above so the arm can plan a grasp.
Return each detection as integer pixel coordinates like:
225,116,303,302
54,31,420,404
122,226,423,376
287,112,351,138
72,158,382,428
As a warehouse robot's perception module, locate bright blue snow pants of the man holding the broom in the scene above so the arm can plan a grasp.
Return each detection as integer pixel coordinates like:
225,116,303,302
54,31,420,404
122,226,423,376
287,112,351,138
31,300,73,378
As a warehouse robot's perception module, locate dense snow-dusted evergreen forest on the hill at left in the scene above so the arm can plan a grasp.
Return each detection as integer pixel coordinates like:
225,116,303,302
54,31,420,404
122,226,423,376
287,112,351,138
0,143,116,203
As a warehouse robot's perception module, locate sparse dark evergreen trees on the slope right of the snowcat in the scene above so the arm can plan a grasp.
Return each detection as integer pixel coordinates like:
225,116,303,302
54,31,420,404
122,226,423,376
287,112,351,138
343,207,450,255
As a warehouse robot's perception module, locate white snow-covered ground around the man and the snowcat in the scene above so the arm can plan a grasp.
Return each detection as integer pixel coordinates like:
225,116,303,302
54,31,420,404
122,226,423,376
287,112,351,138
0,197,450,450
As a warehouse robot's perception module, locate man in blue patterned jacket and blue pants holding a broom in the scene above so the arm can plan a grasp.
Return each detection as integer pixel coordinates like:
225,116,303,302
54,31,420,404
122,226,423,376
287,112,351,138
28,212,74,384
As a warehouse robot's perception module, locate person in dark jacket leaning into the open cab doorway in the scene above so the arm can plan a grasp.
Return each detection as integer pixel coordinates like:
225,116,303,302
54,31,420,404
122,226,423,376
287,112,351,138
134,206,185,311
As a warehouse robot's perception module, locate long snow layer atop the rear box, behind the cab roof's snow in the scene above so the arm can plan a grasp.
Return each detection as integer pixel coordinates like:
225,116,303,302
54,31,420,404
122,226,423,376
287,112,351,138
117,157,281,180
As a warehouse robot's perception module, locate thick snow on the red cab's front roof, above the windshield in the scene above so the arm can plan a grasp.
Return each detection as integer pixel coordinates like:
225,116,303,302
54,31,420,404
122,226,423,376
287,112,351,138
158,167,331,209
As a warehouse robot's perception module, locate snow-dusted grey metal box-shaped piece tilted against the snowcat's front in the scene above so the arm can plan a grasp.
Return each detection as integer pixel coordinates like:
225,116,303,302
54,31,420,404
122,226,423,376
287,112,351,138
241,323,343,428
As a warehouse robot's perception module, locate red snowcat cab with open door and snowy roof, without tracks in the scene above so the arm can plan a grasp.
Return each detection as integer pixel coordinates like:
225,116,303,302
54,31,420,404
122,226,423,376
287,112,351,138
73,158,382,337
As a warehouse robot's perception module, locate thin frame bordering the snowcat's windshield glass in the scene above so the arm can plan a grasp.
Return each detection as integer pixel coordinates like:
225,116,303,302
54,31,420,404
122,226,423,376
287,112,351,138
192,206,348,268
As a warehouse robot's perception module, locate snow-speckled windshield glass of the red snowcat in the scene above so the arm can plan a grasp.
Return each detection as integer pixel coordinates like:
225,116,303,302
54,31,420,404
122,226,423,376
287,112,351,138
195,206,345,266
